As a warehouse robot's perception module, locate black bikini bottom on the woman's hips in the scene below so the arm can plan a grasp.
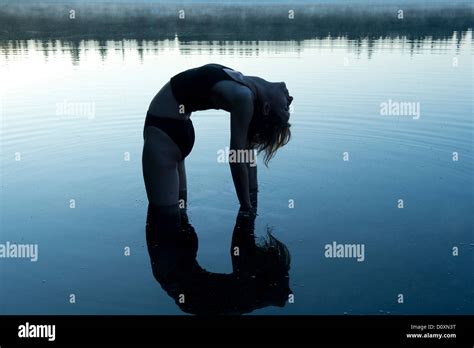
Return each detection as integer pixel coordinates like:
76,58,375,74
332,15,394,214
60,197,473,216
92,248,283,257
144,112,194,160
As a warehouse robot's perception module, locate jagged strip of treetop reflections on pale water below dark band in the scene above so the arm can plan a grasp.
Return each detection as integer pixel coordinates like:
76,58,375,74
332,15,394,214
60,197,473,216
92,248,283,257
0,32,468,65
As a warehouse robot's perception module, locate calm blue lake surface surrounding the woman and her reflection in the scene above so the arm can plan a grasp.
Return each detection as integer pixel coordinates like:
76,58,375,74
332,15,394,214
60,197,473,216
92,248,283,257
0,1,474,314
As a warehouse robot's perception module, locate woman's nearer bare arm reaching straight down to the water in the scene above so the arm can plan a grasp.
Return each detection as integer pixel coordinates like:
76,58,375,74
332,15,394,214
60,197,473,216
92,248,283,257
229,91,253,210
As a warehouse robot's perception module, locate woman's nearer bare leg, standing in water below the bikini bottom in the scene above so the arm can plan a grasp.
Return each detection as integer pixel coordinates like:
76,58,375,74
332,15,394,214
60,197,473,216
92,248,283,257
142,126,181,206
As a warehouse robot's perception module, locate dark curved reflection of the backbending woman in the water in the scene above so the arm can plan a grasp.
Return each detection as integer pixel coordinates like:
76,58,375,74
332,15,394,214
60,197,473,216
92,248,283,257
147,204,291,315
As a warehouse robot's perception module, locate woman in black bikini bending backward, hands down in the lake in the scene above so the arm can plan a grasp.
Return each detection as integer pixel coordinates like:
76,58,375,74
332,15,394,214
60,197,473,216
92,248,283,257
142,64,293,211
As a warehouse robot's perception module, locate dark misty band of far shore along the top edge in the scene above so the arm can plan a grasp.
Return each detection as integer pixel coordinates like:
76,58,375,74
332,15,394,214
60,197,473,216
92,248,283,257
0,3,473,42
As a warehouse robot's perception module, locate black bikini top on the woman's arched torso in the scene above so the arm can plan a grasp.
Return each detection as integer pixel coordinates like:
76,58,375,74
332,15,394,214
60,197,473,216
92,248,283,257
170,64,256,113
